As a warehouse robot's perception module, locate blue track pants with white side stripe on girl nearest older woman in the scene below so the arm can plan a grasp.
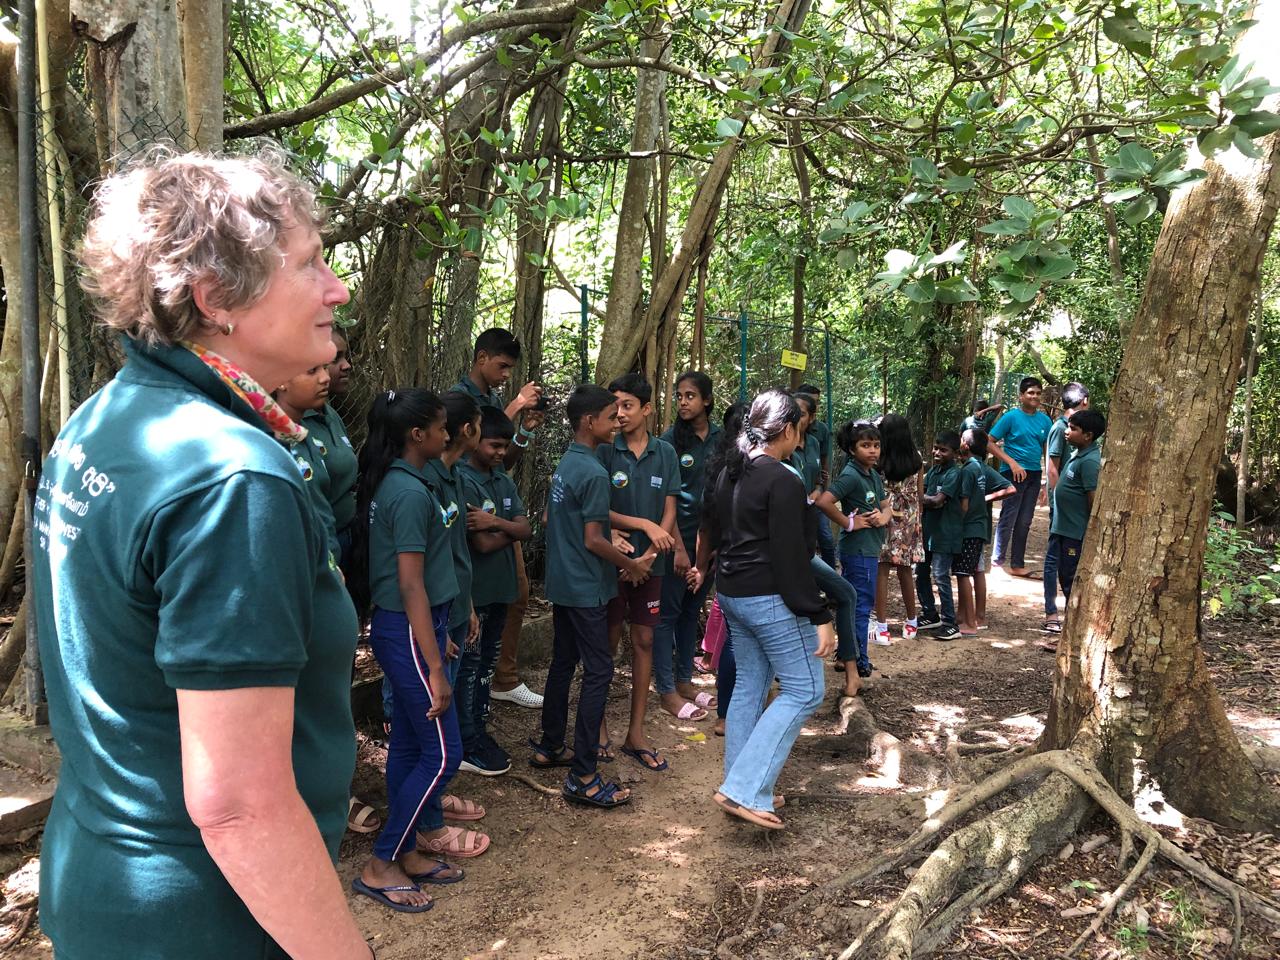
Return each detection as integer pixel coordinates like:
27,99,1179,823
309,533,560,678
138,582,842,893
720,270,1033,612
369,603,462,860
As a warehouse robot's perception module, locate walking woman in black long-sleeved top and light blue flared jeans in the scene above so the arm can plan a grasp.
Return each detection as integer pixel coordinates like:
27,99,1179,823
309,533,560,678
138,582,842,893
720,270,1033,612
707,390,836,829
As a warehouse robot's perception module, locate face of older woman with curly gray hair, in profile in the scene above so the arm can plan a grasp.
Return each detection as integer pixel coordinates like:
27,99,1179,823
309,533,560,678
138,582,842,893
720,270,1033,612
228,224,351,374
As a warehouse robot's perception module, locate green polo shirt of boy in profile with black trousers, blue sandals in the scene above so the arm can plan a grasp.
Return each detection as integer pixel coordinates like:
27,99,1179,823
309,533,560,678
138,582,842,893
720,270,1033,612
545,443,618,607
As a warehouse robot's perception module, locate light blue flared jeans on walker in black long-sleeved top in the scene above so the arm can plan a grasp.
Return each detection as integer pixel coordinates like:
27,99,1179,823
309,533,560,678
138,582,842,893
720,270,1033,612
719,594,826,810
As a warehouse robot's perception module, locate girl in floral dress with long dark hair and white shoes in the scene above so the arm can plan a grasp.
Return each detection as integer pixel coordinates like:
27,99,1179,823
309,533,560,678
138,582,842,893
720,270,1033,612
872,413,924,646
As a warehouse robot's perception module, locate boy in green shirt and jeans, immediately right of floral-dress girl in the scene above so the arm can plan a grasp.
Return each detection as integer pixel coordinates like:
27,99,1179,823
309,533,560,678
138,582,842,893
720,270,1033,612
915,430,969,640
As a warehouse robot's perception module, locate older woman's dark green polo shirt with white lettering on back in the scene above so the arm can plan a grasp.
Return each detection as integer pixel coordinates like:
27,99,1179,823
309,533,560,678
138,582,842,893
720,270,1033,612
29,342,357,960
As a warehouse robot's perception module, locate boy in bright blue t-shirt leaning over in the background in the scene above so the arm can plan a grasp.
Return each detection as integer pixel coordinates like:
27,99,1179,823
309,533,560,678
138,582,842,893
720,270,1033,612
991,376,1053,579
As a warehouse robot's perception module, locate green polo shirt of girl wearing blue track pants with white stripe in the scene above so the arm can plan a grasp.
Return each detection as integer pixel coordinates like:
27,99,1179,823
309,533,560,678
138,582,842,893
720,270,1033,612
369,460,458,613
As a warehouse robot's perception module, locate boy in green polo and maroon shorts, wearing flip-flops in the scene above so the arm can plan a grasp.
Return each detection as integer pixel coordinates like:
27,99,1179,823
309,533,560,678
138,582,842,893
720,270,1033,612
595,374,689,771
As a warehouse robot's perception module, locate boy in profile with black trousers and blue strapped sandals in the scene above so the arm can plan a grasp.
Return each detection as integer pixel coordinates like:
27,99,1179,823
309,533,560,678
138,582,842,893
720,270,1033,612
530,384,658,808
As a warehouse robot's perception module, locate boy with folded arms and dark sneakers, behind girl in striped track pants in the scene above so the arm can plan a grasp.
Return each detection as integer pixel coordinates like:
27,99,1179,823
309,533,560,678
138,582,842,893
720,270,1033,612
458,407,532,776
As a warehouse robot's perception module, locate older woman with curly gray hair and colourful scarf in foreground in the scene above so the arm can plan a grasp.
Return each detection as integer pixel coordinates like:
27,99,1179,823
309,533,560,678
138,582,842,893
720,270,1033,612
32,155,378,960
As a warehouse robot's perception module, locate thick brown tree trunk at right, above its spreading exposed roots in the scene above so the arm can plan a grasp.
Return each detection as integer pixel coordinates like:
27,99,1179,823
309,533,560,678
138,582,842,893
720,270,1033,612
1043,118,1280,829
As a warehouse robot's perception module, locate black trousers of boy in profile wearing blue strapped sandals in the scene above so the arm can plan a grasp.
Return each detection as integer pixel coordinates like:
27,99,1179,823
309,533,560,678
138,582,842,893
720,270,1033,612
540,603,613,781
